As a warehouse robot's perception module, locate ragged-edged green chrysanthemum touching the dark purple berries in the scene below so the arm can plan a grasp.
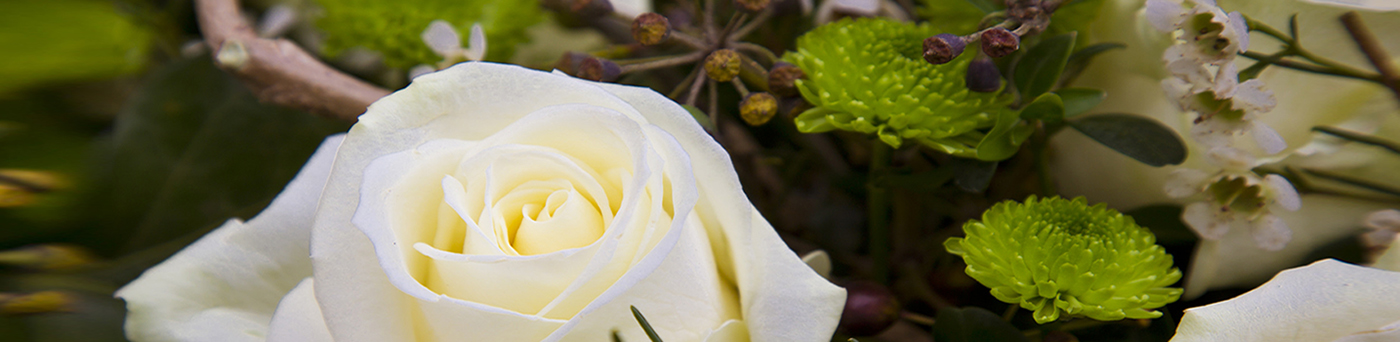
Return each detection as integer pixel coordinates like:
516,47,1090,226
784,18,1011,157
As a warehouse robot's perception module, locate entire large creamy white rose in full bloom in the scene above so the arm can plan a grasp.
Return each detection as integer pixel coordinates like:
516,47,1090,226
118,63,846,341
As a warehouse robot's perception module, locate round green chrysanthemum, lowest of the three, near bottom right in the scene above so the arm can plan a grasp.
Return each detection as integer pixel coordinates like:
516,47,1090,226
944,196,1182,324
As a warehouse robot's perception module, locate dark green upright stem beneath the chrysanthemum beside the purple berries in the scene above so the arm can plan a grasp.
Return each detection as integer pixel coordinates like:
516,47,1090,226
865,139,890,283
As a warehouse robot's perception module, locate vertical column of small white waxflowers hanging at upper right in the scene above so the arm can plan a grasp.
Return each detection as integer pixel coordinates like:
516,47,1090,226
1147,0,1301,251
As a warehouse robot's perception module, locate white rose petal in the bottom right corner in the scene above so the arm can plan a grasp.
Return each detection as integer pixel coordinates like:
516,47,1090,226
1172,259,1400,342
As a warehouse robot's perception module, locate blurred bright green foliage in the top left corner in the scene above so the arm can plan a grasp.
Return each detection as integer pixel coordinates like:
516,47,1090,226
0,0,153,94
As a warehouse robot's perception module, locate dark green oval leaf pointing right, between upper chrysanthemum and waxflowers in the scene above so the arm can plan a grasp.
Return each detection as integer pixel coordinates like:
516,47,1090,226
1070,114,1186,167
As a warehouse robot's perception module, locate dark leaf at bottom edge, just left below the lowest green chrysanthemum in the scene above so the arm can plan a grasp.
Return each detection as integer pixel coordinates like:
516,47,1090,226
934,307,1026,342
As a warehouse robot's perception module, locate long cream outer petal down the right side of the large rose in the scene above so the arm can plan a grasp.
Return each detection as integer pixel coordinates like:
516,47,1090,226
588,78,846,341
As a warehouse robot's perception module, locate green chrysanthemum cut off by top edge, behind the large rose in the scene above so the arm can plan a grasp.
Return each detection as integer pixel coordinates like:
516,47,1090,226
316,0,545,69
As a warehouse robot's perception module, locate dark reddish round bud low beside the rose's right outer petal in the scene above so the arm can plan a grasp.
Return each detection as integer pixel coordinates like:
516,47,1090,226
839,282,900,336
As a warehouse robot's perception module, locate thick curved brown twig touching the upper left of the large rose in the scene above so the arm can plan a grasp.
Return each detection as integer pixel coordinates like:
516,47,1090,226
195,0,389,121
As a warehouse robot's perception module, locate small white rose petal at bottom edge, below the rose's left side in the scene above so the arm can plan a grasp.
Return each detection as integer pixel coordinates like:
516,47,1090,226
267,276,333,342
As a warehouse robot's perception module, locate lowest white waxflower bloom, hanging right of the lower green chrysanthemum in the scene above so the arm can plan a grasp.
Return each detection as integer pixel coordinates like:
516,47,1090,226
1163,147,1302,251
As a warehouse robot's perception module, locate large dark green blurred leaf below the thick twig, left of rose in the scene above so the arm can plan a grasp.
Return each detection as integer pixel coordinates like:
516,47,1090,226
83,56,349,252
